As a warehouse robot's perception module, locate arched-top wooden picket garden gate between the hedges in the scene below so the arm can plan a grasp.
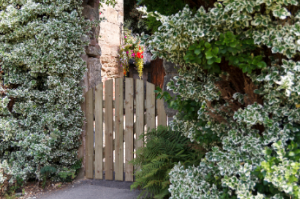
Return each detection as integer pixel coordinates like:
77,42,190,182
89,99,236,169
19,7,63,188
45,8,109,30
85,78,167,181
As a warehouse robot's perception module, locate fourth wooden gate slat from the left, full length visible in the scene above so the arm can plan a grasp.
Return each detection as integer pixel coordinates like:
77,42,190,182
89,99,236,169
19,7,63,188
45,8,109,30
115,78,124,181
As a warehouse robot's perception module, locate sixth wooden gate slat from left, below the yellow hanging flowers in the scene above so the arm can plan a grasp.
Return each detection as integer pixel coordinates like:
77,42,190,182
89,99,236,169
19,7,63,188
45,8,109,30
135,79,145,150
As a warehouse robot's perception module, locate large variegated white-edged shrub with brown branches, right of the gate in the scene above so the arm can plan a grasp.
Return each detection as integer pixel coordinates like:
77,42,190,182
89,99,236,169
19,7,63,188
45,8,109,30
140,0,300,199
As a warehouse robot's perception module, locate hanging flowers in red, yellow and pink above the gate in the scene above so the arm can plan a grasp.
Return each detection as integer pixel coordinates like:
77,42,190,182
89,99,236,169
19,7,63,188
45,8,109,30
120,31,144,78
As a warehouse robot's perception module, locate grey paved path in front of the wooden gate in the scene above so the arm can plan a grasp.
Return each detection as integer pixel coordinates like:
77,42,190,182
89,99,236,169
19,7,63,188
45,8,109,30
37,180,140,199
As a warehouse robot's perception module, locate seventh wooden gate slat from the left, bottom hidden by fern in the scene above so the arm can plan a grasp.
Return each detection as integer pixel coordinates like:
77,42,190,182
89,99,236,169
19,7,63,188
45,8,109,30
146,82,156,131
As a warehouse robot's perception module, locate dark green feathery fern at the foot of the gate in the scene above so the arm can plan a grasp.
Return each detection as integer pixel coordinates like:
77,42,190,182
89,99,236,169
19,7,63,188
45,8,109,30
131,126,202,199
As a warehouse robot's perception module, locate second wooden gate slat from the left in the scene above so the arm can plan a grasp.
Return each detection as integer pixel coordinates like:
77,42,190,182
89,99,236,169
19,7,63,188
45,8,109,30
95,83,103,179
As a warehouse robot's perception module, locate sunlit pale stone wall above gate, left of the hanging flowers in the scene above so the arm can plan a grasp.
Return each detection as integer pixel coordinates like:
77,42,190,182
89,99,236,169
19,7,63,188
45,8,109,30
98,0,124,82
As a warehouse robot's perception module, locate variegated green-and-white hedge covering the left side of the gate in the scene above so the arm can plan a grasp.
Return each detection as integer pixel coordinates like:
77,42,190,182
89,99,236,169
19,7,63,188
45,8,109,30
0,0,91,188
